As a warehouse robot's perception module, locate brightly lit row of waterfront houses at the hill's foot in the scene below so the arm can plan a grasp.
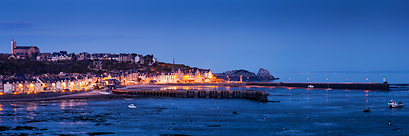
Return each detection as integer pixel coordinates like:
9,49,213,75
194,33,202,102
0,69,218,94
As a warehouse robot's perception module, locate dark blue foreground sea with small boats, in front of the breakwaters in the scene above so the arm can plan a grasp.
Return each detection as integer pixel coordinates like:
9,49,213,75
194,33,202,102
0,86,409,135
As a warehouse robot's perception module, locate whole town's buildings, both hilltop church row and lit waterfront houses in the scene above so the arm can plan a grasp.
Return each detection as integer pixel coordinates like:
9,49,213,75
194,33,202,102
0,39,222,94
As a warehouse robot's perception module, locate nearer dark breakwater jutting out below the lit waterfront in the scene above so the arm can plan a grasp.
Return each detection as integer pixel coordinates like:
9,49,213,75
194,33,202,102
124,90,268,102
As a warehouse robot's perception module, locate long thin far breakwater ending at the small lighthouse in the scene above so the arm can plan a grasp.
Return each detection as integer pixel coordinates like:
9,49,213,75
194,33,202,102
247,82,389,90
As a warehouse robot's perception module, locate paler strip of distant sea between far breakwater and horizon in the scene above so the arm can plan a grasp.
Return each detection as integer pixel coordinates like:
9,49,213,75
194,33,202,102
272,71,409,84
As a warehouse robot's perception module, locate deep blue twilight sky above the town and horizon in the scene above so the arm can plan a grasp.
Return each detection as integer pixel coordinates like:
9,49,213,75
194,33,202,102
0,0,409,73
